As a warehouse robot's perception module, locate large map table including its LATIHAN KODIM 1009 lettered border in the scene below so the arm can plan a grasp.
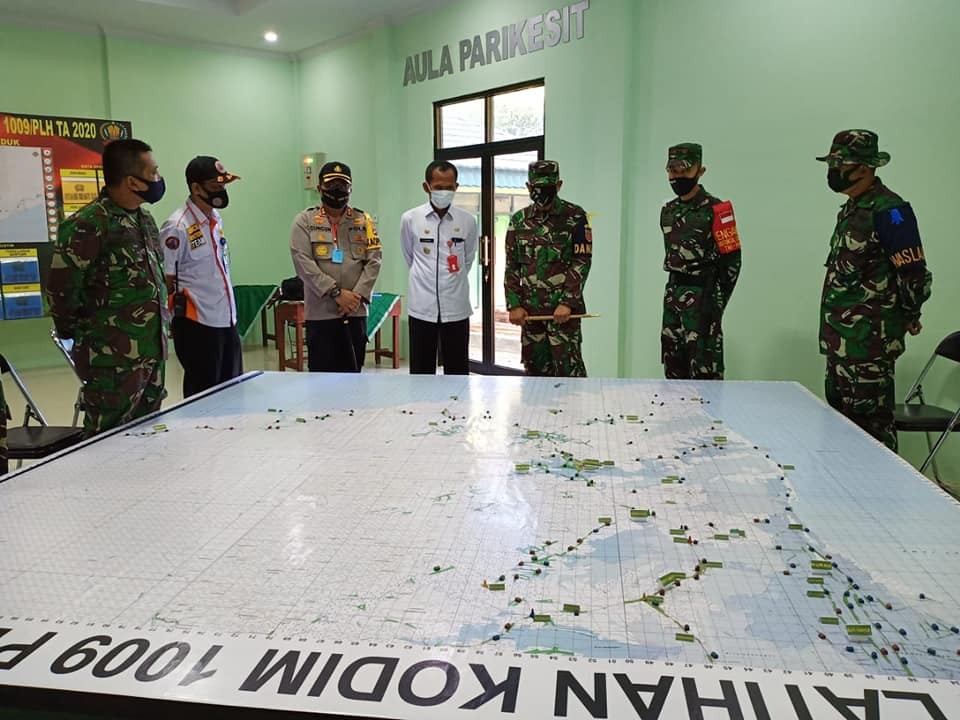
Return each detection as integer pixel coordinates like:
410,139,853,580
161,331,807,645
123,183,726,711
0,373,960,720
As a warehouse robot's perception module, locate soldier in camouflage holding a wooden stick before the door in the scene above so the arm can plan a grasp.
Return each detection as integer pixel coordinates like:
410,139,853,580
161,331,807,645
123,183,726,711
504,160,593,377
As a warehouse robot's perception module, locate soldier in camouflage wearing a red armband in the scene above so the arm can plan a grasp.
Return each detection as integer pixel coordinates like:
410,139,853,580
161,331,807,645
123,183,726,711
660,143,740,380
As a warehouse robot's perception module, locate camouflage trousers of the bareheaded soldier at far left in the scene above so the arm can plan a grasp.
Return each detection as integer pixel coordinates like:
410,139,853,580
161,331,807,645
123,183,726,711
81,358,165,435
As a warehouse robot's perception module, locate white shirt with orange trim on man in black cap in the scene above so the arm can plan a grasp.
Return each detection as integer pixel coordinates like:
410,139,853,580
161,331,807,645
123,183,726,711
160,200,237,328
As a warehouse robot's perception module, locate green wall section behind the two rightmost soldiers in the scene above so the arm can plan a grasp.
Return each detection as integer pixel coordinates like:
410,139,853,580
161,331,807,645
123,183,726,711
624,0,960,485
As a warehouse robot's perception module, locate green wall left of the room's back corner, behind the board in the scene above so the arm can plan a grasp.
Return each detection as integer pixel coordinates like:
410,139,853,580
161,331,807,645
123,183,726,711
0,24,300,368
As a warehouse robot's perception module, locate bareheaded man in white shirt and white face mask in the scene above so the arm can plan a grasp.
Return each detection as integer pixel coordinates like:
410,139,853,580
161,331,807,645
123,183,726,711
400,161,477,375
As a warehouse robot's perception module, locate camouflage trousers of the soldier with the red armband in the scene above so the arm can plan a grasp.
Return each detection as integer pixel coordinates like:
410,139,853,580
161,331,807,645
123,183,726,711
660,284,723,380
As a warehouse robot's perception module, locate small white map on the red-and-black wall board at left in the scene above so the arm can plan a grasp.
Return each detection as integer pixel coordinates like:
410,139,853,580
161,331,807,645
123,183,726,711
0,146,47,244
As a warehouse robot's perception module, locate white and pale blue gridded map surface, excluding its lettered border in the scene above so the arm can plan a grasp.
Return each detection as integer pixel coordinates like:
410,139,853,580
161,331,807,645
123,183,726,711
0,373,960,680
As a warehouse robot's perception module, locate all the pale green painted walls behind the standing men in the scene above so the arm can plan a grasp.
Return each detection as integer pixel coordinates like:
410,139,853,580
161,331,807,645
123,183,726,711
0,0,960,478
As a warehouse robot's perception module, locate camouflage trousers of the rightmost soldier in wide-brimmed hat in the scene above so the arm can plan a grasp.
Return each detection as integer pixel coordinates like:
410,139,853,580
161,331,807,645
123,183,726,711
825,355,897,452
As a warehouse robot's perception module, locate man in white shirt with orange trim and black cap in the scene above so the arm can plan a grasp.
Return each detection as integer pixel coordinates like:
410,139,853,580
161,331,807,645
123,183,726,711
160,155,243,397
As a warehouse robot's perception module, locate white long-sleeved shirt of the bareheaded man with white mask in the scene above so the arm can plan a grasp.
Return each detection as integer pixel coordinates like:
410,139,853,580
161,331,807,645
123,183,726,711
400,203,477,322
